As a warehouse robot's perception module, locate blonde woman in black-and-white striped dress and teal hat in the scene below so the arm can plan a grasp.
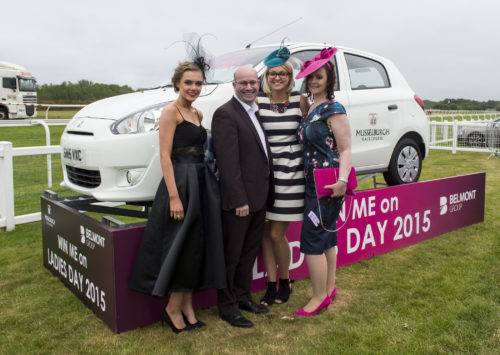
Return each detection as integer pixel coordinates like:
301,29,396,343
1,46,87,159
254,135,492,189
257,47,308,306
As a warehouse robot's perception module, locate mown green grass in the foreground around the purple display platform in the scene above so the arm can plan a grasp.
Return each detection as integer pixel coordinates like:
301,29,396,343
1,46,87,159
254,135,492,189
0,151,500,354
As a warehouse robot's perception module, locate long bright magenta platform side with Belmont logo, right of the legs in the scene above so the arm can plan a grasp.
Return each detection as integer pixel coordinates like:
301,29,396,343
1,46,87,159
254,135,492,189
252,173,486,291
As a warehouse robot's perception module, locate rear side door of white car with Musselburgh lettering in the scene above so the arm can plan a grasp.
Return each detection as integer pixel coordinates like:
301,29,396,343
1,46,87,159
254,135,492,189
343,51,401,172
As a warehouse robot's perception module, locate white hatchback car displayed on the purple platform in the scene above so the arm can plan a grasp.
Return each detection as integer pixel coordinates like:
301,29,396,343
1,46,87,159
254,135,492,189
61,43,429,202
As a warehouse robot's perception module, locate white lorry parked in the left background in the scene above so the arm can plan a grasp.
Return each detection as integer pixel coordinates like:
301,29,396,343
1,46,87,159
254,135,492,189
0,62,37,120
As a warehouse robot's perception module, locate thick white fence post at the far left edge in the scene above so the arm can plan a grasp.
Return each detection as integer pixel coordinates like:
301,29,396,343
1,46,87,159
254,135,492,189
0,142,15,231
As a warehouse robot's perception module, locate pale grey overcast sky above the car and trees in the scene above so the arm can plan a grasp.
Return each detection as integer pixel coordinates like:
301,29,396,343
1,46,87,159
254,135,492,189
0,0,500,100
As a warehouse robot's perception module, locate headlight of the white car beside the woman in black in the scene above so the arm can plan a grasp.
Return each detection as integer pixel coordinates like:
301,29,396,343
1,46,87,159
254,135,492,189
111,102,167,134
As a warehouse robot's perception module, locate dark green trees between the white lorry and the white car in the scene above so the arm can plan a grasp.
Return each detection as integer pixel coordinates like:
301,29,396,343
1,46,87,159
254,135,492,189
37,80,134,104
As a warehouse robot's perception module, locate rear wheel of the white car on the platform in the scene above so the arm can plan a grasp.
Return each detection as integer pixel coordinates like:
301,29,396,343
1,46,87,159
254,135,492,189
384,138,422,185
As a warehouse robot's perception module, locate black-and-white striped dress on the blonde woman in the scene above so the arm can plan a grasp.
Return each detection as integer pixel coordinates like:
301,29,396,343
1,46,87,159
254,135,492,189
258,92,305,222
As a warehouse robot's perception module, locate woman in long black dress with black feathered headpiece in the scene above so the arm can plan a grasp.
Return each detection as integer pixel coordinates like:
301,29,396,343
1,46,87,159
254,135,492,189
129,62,226,333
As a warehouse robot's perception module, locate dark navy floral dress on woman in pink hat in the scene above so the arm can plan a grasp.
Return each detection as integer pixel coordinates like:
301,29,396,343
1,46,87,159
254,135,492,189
297,100,346,255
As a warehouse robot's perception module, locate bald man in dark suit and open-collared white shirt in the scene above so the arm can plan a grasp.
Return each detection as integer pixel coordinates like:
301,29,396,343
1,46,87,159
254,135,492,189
212,66,272,328
